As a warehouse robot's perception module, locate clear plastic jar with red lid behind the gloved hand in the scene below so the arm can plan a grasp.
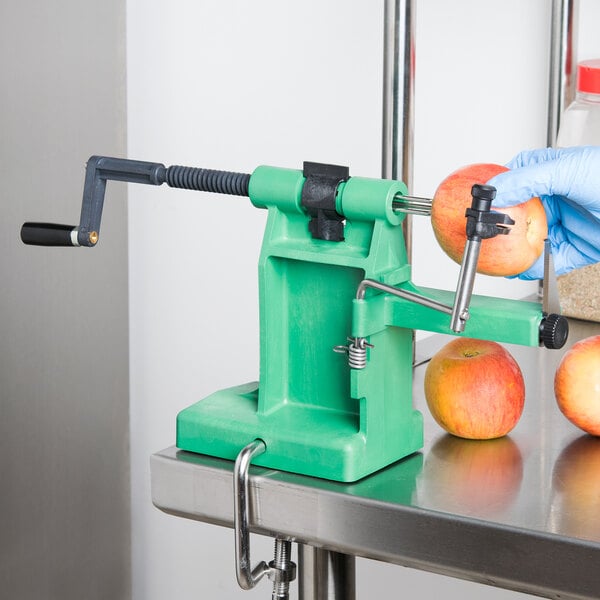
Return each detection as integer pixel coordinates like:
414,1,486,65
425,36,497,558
556,59,600,322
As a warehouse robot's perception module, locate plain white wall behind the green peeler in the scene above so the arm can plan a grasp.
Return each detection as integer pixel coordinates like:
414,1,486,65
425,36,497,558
128,0,600,600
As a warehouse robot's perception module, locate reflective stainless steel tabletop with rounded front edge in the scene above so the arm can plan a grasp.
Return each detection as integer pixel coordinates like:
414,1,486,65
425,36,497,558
151,321,600,598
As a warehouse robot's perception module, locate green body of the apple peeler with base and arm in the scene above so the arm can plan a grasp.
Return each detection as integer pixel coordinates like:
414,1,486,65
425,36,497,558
177,167,542,482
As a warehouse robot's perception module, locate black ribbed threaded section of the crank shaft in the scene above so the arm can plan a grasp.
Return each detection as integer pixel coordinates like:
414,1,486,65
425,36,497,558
166,165,250,196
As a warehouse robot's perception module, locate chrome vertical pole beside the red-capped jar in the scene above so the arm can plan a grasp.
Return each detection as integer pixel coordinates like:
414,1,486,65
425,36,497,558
546,0,579,146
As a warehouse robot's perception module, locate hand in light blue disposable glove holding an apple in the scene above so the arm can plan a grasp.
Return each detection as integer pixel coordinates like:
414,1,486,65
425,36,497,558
488,146,600,279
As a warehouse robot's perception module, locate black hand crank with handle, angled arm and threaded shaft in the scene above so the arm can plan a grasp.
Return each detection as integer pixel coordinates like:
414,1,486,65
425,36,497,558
21,156,250,246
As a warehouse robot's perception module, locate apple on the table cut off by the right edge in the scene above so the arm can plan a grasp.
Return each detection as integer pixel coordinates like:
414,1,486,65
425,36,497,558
554,335,600,436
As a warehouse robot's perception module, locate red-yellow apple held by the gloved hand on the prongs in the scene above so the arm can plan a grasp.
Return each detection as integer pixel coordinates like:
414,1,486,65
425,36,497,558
431,163,548,277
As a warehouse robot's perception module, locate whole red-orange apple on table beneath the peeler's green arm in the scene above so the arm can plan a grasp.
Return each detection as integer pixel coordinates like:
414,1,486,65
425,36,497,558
425,338,525,440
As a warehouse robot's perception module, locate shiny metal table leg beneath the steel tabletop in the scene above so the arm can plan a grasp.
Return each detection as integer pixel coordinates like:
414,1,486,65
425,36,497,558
298,544,356,600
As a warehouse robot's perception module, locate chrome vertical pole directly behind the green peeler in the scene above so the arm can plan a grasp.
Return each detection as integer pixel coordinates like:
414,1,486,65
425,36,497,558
381,0,416,261
